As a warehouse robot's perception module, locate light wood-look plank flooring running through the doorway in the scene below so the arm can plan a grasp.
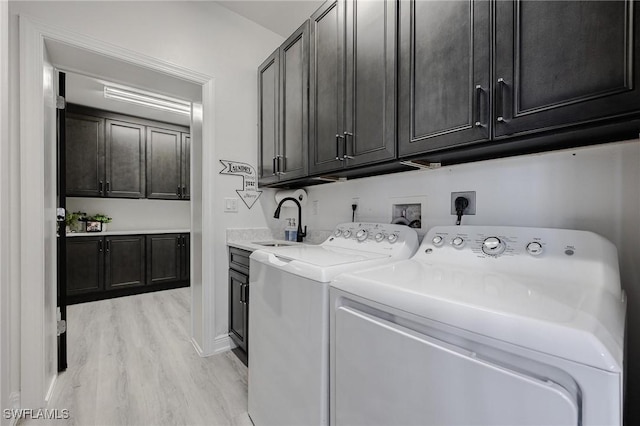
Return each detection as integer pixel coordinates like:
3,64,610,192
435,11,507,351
19,288,251,426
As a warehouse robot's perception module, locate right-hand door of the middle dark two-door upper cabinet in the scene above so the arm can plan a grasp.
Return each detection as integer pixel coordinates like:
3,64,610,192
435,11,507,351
344,0,398,166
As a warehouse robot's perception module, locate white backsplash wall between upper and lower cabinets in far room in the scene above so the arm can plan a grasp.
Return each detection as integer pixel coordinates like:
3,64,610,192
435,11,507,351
67,197,191,231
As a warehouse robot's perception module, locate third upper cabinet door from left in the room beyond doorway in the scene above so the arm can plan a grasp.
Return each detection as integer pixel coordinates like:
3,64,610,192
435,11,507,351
147,127,182,200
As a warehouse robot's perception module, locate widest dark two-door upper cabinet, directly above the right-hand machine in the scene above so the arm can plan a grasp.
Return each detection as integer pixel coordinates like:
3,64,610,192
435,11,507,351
398,0,640,157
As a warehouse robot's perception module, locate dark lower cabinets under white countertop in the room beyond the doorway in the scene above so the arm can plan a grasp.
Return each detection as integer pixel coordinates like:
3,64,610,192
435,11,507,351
66,234,190,304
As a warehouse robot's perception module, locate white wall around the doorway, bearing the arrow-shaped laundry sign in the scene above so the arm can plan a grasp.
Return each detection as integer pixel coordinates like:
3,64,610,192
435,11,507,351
3,1,283,404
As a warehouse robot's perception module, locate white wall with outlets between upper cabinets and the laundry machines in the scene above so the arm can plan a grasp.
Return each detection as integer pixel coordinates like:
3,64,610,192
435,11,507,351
262,140,640,424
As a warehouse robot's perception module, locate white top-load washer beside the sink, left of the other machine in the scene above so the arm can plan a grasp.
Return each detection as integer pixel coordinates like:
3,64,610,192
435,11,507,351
249,223,418,426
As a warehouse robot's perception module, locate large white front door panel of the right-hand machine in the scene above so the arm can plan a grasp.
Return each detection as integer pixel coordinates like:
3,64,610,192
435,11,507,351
331,306,580,426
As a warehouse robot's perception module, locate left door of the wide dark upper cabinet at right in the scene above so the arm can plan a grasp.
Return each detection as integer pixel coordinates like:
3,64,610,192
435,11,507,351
398,0,490,156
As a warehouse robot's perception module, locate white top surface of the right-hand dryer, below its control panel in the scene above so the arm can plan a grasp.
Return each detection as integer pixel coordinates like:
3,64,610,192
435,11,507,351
331,260,626,372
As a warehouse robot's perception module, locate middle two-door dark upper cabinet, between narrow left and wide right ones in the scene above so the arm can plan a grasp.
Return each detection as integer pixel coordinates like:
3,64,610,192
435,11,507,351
309,0,398,174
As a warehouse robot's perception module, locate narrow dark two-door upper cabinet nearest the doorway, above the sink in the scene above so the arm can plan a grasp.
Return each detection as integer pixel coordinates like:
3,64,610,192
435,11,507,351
258,21,309,185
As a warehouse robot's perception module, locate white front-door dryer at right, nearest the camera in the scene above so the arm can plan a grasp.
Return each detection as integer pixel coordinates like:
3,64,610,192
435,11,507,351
330,226,626,426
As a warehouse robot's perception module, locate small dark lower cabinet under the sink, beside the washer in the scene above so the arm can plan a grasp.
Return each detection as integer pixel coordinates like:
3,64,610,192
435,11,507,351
229,247,251,357
